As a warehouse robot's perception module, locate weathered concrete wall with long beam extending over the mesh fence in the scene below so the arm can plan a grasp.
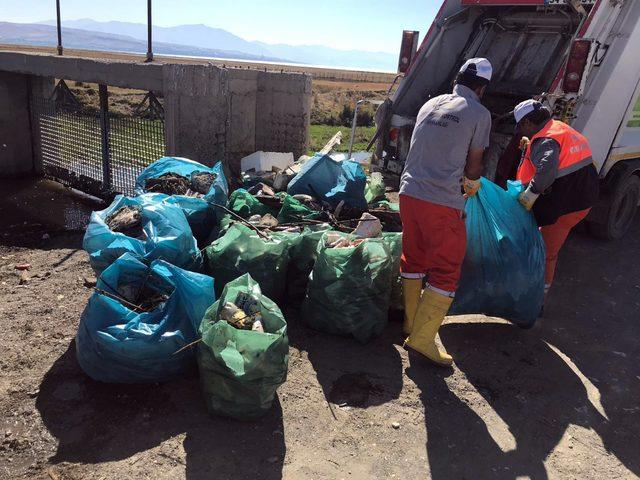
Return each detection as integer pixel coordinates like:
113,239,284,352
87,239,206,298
0,52,311,175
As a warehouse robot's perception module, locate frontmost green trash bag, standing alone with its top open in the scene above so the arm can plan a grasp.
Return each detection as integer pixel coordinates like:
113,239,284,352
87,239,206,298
198,274,289,420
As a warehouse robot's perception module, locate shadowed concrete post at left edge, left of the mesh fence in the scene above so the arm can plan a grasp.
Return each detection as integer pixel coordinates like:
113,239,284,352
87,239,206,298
0,71,34,177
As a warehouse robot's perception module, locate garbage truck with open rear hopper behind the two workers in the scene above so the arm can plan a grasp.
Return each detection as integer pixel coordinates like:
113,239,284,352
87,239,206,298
372,0,640,239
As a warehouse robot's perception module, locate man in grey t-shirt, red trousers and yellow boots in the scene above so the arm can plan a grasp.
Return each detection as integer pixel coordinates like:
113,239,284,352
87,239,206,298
400,58,492,366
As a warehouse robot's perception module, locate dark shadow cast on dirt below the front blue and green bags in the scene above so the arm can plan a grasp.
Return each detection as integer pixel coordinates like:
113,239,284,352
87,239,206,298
36,342,285,479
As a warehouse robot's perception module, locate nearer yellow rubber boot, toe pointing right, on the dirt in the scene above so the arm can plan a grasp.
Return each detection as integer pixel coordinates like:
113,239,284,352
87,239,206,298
404,288,453,366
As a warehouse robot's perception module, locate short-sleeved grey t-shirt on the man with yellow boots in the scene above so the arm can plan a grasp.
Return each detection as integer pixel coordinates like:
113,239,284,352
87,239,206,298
400,85,491,210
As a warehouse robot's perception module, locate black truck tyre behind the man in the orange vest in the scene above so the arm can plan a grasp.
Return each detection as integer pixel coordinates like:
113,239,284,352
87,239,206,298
589,175,640,240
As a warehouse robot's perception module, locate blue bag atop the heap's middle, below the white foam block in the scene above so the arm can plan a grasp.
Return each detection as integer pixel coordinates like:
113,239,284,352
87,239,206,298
287,154,367,211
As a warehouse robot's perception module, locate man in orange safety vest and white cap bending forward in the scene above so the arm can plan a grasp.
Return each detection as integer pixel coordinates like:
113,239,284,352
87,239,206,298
513,100,599,293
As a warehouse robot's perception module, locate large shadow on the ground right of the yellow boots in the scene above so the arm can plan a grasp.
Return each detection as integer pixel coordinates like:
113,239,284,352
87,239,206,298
407,219,640,479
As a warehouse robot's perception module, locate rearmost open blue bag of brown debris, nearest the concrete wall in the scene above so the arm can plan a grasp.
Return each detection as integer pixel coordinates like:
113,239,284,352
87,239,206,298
135,157,229,239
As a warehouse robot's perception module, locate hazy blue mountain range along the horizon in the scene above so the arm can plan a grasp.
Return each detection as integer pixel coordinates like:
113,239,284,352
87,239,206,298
0,19,397,71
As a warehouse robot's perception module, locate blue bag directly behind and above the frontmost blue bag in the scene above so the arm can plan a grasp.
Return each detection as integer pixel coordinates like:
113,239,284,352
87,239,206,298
82,193,202,275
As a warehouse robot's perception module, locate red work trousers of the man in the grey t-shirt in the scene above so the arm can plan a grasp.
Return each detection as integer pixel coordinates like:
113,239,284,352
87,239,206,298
400,195,467,294
